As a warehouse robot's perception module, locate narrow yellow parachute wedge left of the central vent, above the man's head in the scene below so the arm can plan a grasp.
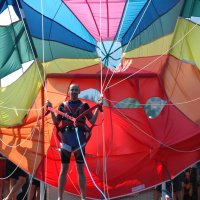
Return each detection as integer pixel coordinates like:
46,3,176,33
45,58,100,74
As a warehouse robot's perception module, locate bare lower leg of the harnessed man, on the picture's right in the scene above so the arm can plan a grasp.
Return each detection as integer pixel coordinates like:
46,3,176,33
76,163,86,200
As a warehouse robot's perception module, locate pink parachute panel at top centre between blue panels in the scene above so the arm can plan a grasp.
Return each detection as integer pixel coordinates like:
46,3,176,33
63,0,125,41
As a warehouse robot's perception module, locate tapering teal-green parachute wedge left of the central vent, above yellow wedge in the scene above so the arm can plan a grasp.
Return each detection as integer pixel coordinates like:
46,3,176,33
33,38,98,62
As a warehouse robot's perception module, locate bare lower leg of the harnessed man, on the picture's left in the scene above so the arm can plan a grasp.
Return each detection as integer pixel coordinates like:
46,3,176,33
58,163,69,200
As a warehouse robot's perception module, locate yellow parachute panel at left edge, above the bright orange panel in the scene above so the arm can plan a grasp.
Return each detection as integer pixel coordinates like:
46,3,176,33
0,62,43,127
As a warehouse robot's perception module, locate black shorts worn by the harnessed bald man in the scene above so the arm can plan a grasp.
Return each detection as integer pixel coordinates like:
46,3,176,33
61,147,85,164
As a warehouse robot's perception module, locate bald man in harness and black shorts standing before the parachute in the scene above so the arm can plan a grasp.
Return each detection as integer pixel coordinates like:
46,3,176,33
46,83,103,200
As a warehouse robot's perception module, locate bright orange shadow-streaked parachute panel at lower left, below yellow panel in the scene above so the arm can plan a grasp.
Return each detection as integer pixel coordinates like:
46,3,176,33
0,122,50,174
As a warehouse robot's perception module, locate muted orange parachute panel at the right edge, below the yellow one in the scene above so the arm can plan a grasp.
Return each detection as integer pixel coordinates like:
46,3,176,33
160,56,200,125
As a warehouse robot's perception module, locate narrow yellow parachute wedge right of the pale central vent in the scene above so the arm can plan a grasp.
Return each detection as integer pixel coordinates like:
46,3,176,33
123,34,173,58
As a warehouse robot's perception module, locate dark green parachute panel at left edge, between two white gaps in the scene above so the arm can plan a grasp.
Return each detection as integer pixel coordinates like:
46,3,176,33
0,21,34,78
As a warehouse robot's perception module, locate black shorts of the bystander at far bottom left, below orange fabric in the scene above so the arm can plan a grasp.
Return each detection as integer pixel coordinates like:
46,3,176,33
4,159,26,179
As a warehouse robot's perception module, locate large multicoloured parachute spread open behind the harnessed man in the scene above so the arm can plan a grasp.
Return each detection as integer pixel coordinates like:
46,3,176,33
0,0,200,199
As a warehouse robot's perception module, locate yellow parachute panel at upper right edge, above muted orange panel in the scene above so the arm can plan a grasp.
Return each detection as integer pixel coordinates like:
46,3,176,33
170,18,200,69
